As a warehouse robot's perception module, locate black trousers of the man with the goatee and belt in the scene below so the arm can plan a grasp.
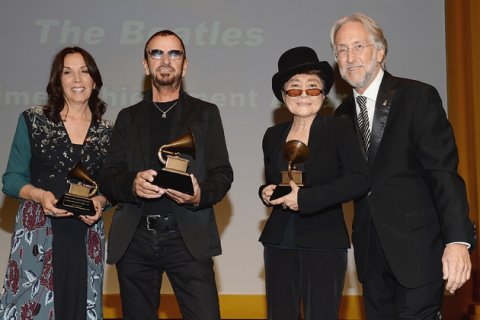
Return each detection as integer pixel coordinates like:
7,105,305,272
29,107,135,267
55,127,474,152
117,228,220,320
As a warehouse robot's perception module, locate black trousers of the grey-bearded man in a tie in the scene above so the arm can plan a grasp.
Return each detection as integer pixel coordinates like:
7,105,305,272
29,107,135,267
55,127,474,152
362,223,444,320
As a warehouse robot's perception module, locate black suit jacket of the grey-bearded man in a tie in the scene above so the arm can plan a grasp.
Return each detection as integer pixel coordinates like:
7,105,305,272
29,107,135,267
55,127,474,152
336,72,474,288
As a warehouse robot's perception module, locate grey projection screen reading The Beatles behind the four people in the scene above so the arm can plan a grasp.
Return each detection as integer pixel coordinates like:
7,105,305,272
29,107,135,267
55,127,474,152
0,0,447,295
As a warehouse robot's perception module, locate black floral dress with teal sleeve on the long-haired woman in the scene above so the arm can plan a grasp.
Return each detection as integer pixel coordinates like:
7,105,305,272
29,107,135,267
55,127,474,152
0,107,112,320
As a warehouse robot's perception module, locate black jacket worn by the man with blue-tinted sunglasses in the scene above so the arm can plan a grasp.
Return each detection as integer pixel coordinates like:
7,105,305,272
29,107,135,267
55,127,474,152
100,92,233,263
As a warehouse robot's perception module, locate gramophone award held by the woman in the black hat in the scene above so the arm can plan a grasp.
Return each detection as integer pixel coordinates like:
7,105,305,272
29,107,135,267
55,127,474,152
270,140,310,200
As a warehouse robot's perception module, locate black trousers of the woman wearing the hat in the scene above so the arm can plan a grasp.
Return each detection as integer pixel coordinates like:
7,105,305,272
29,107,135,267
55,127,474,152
264,246,347,320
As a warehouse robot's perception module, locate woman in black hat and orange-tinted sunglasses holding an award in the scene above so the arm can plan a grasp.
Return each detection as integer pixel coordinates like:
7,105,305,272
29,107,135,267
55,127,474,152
259,47,369,320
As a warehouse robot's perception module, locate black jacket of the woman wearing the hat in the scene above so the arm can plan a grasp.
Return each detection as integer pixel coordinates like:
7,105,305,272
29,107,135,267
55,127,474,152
260,115,368,249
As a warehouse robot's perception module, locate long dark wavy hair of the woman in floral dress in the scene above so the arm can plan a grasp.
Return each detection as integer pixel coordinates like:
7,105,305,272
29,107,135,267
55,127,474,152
44,47,107,123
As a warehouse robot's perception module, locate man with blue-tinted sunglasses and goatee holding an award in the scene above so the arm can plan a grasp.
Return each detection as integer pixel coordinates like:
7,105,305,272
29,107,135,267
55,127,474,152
101,30,233,320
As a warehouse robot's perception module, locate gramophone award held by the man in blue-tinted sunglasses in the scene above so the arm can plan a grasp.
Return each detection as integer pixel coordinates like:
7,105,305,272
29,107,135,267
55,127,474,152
153,130,196,195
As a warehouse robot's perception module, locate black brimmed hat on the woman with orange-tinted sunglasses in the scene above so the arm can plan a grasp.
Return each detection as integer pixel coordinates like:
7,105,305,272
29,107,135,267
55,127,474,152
272,47,334,102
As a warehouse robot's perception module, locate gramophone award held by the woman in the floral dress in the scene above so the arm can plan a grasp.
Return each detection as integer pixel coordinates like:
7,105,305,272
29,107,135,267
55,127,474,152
56,161,98,216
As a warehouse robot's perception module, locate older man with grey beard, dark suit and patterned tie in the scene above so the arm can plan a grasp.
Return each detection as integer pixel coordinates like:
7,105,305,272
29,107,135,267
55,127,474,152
331,13,475,320
